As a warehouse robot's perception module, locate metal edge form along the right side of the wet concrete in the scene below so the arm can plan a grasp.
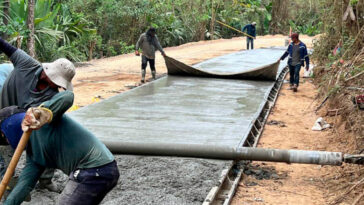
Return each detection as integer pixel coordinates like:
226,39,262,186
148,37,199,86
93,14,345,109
203,67,288,205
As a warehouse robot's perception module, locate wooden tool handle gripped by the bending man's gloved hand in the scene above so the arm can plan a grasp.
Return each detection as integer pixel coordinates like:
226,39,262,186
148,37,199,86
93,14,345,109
0,131,32,200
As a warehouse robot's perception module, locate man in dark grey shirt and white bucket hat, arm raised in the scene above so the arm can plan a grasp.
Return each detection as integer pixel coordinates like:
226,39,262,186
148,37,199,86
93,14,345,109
0,38,75,191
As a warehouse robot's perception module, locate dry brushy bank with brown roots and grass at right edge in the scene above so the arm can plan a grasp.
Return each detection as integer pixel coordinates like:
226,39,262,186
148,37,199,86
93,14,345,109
313,0,364,143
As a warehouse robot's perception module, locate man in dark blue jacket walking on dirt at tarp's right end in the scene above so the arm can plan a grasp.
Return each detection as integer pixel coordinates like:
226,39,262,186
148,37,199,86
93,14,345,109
280,33,310,92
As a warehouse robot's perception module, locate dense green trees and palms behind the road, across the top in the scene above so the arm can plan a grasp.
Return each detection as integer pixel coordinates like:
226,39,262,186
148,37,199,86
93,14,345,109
0,0,322,61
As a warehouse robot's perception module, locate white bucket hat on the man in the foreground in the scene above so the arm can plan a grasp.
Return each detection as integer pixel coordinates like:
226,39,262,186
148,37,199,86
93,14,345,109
42,58,76,91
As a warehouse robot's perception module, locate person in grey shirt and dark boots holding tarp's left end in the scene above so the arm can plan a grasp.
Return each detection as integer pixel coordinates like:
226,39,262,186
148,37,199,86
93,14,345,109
135,27,166,83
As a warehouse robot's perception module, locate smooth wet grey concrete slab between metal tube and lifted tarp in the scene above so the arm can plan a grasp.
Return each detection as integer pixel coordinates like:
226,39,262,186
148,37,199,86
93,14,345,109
71,49,284,150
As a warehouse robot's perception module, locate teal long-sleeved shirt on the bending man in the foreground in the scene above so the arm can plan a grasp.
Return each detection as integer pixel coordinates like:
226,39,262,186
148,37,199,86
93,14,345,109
4,91,114,205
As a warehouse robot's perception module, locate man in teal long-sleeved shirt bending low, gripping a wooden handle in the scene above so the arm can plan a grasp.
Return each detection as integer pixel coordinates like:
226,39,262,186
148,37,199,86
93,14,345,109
1,91,119,205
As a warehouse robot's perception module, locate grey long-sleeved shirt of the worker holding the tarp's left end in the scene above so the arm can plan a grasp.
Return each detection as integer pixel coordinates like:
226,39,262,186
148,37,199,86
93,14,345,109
135,33,164,59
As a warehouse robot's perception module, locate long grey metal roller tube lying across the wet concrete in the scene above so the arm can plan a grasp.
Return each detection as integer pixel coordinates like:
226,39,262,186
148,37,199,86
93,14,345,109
104,141,354,166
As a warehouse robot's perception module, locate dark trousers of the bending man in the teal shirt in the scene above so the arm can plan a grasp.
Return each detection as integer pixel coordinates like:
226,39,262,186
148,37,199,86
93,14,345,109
59,161,120,205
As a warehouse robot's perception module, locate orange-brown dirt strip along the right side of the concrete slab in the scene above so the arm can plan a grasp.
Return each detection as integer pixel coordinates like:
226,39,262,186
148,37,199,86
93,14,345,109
232,73,342,205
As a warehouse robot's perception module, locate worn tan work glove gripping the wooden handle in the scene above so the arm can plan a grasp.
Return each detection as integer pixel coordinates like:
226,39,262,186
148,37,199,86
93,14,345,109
21,107,53,132
